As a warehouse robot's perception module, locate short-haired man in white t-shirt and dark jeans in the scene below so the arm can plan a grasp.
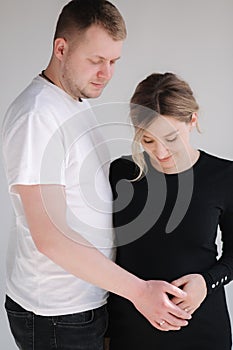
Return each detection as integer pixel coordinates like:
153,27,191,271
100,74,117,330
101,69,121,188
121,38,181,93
3,0,190,350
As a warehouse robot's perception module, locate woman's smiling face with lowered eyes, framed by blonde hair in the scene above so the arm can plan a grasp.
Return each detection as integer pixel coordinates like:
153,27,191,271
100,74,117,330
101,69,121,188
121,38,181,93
141,113,197,173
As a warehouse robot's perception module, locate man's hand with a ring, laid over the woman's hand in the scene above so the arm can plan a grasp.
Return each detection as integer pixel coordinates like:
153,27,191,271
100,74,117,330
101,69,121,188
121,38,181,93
134,281,191,331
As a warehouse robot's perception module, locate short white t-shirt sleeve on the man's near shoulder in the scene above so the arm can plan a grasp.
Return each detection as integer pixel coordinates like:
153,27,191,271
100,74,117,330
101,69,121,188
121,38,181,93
3,113,65,190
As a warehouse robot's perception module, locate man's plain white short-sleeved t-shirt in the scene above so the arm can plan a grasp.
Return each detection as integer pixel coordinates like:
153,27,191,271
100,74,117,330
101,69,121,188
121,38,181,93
2,76,114,316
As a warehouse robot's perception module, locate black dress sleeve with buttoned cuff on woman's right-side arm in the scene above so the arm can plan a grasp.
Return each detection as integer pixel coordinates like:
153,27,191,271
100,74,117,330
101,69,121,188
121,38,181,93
201,167,233,294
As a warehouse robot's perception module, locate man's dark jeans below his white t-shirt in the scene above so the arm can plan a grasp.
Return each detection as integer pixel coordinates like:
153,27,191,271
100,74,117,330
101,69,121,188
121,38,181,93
5,296,107,350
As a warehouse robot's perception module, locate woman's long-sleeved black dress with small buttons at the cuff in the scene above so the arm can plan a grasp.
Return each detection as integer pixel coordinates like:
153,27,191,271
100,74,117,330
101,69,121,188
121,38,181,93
108,151,233,350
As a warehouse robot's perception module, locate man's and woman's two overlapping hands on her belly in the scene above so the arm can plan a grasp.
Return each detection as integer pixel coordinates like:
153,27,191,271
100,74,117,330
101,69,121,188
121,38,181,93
134,274,207,331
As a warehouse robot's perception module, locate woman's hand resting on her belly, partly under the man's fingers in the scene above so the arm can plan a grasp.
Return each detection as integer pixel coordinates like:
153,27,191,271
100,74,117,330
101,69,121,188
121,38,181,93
171,274,207,314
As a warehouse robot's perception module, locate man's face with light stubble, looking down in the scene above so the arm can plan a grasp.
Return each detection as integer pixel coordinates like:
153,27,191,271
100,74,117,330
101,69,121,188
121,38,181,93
56,25,123,98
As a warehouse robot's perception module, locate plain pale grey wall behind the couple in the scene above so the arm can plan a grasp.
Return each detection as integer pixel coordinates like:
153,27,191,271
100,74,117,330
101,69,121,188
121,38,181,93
0,0,233,350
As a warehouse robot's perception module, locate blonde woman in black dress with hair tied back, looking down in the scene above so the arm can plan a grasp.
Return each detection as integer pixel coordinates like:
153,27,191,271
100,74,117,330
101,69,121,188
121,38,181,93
109,73,233,350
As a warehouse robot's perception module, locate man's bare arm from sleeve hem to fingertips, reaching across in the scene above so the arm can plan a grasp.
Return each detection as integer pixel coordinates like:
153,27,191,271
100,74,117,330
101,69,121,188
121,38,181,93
13,185,190,330
